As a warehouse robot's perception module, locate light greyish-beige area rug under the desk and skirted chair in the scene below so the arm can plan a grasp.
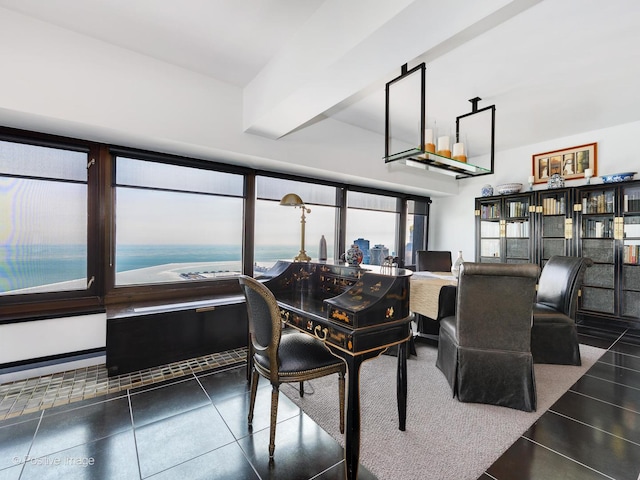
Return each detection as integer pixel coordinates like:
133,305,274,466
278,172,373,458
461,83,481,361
281,344,605,480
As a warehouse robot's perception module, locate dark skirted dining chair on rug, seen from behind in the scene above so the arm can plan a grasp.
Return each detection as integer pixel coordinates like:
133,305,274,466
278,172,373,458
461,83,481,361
436,262,540,412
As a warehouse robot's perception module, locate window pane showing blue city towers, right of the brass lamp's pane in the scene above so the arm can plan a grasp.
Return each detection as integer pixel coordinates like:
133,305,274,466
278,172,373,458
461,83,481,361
346,191,401,265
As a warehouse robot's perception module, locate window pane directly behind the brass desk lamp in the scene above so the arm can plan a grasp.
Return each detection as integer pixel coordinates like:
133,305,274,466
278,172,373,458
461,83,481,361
254,176,337,273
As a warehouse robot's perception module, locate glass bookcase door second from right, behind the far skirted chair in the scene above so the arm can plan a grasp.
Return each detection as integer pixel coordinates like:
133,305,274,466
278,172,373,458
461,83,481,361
577,186,616,315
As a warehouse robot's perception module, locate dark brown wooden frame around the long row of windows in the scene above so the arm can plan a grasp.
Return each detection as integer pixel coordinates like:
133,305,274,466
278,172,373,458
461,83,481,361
0,127,431,324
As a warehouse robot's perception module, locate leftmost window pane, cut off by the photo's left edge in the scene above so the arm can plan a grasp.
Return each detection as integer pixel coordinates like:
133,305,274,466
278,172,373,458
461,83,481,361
0,140,89,296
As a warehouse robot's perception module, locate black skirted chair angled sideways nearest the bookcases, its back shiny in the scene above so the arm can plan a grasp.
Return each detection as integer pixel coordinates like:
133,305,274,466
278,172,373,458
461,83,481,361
531,255,593,365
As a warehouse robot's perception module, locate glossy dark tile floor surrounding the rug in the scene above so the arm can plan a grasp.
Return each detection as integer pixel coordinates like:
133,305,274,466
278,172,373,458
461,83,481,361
0,327,640,480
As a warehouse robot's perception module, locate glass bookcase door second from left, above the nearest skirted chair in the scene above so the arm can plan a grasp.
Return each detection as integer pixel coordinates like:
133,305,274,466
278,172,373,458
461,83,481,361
503,194,531,263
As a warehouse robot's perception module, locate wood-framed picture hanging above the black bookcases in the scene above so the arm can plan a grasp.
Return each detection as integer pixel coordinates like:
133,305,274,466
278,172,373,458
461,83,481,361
532,143,598,183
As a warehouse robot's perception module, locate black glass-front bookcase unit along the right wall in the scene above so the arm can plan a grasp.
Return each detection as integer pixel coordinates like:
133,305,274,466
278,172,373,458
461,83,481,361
475,180,640,328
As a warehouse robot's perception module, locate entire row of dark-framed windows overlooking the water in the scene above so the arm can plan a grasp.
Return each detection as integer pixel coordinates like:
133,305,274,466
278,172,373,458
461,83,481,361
0,128,430,322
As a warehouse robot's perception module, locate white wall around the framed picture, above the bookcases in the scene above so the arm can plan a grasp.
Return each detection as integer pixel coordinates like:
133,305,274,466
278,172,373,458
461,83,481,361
429,119,640,261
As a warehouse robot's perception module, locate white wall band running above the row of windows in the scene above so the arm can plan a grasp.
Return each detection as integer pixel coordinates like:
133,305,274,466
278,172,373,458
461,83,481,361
0,8,458,198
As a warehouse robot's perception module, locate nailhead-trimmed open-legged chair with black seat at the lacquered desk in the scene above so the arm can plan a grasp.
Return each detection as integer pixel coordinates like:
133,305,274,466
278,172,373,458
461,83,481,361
239,275,346,458
